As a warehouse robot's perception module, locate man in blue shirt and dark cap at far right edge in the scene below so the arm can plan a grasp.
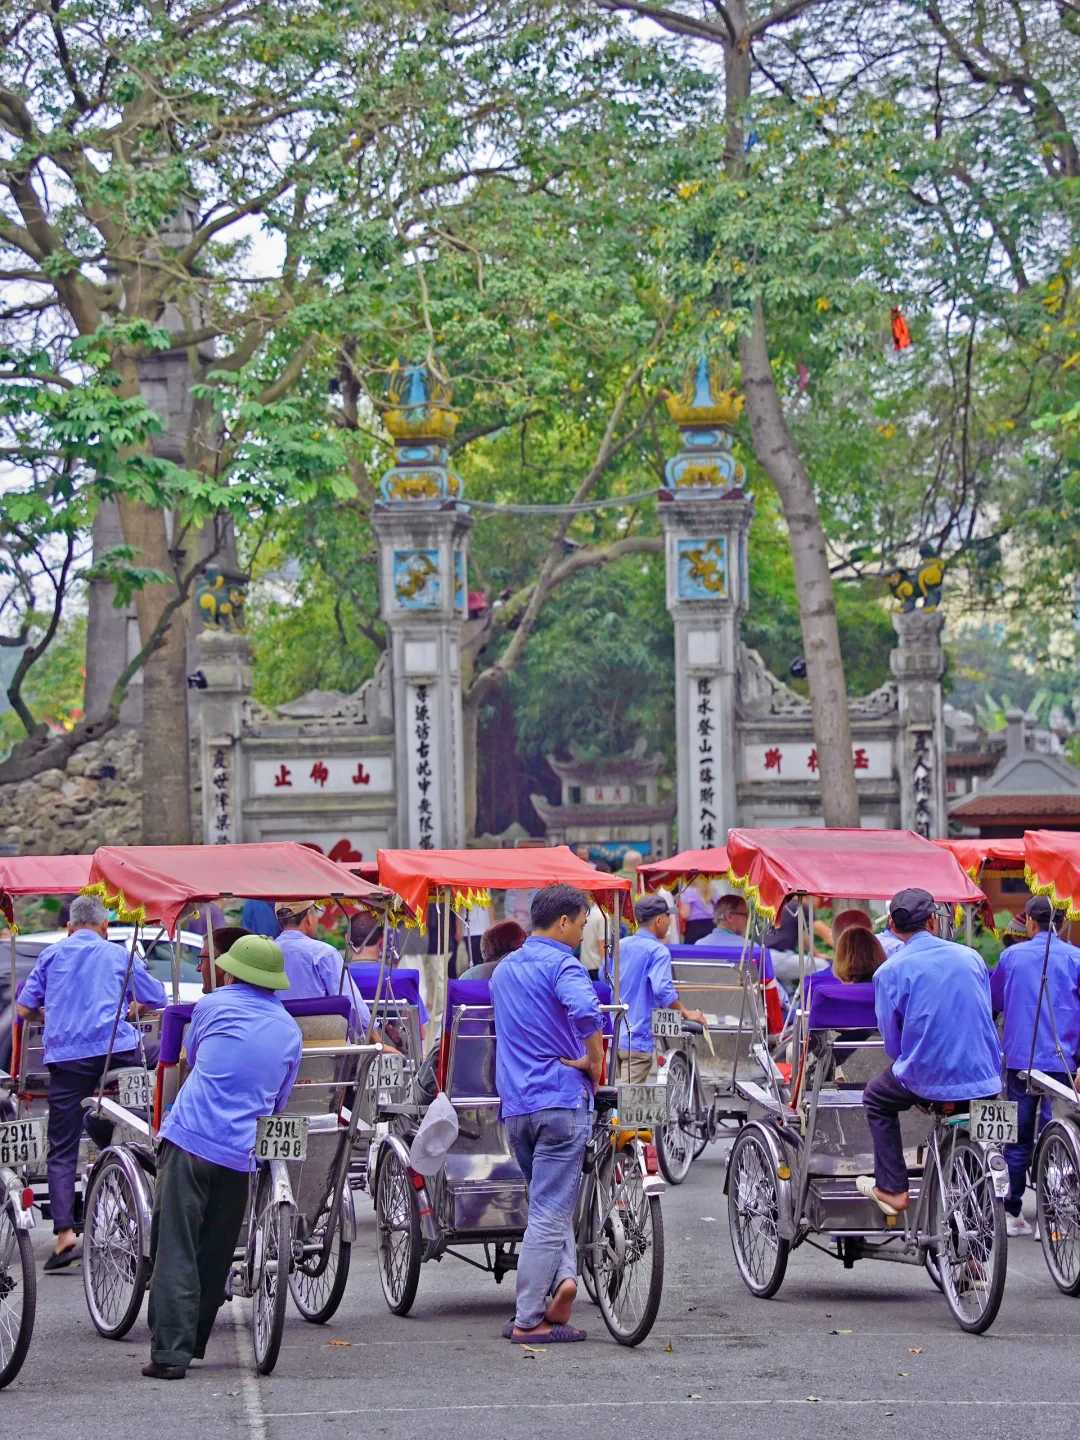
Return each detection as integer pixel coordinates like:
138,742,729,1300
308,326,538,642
991,896,1080,1236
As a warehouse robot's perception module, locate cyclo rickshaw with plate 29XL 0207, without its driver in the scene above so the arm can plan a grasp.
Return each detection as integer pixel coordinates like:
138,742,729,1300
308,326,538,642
724,831,1008,1333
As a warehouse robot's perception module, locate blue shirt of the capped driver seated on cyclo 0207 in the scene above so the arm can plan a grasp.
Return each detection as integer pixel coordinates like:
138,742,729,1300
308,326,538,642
874,930,1001,1100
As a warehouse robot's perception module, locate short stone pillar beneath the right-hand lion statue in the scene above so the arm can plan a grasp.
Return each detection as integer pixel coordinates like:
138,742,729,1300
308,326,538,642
888,609,949,840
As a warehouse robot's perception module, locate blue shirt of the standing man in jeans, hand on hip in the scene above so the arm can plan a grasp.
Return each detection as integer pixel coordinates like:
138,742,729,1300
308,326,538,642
488,935,600,1119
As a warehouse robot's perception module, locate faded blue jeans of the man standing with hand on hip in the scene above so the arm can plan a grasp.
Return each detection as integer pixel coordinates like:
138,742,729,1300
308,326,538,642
505,1107,592,1331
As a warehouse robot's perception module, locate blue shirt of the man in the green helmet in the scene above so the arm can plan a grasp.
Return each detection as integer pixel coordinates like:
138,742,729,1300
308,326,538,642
161,981,304,1171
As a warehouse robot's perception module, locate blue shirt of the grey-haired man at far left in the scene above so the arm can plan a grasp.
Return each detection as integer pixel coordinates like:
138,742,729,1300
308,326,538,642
19,929,166,1066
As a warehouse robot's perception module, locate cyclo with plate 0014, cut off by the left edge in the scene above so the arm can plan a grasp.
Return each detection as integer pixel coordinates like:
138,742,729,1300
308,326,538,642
0,855,89,1390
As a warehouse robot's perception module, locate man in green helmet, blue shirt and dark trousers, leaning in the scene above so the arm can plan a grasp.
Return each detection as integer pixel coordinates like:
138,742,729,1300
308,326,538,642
143,935,302,1380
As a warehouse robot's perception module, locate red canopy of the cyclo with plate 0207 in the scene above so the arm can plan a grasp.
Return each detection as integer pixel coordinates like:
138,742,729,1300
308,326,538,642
727,828,986,917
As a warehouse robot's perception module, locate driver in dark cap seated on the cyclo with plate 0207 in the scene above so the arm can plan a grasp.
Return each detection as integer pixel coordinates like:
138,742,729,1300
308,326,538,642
855,888,1001,1215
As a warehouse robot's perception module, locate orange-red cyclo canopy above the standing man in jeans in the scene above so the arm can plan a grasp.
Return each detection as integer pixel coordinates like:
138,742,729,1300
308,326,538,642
379,845,631,919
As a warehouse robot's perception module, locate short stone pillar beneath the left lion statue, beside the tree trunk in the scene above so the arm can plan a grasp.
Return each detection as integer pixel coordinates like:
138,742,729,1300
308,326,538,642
192,626,251,845
